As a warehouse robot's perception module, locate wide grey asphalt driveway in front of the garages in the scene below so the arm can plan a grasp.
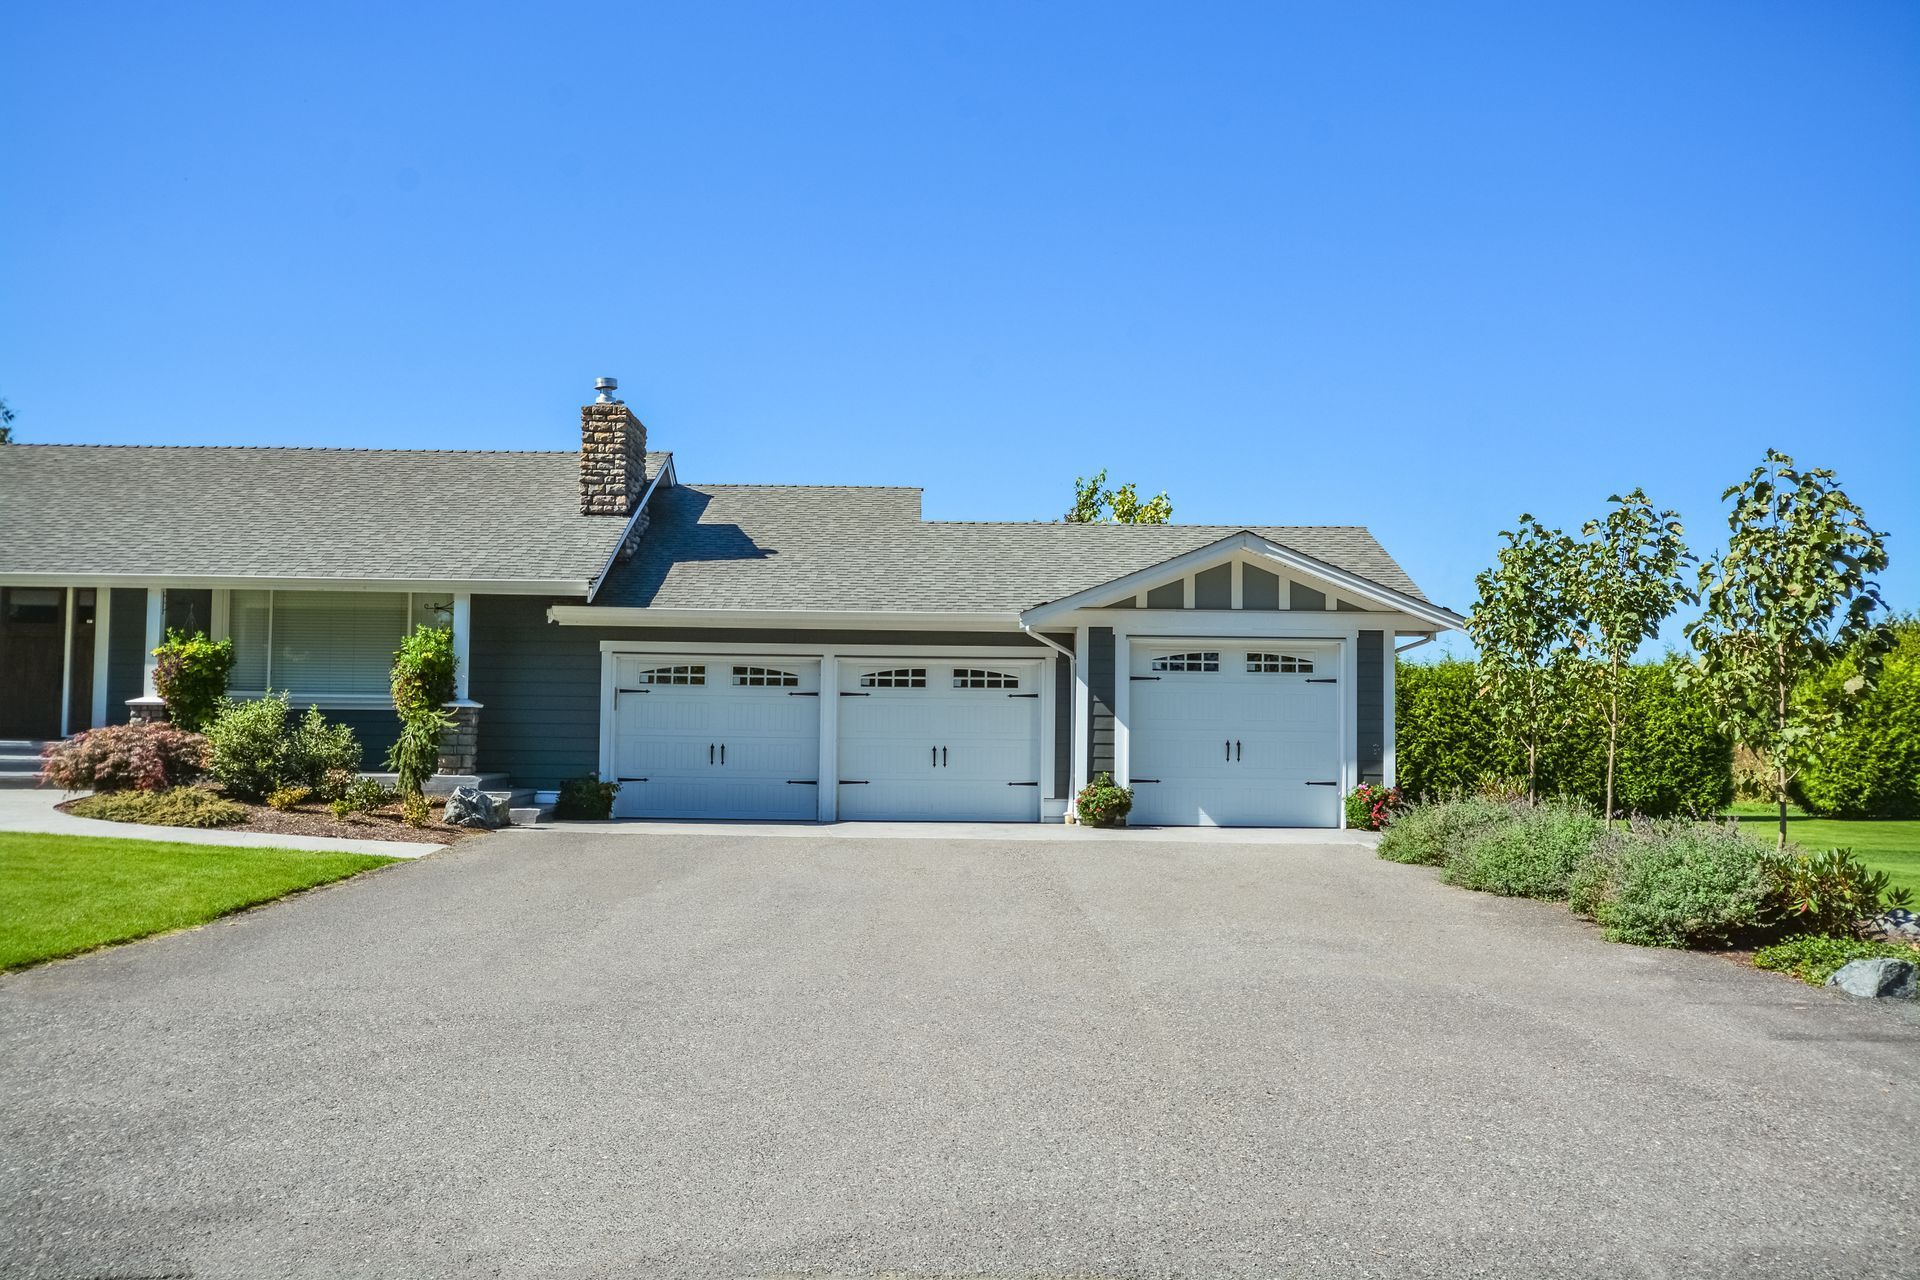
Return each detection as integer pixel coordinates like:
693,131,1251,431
0,829,1920,1280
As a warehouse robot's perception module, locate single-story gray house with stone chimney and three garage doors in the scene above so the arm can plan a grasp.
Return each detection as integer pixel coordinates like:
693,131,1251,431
0,380,1461,827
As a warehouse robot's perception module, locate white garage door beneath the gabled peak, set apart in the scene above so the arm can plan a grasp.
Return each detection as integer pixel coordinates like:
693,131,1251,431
1127,641,1340,827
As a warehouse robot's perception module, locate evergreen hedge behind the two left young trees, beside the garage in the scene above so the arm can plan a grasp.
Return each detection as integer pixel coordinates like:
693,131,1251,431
1394,660,1734,818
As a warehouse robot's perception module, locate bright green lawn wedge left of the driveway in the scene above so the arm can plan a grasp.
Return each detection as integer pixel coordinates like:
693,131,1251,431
0,833,397,969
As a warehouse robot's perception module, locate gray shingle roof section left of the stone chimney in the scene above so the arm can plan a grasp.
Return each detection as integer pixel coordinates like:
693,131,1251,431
0,445,668,583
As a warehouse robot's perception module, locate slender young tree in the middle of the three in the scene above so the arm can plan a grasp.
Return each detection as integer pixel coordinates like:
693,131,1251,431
1572,489,1693,821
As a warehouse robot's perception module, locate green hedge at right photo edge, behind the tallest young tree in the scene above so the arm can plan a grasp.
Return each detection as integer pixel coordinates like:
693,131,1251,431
1768,618,1920,818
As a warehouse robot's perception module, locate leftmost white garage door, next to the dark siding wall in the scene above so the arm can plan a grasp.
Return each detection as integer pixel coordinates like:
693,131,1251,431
612,654,820,819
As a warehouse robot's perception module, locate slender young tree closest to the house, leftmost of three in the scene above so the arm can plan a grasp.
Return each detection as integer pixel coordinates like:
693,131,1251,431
1467,514,1582,796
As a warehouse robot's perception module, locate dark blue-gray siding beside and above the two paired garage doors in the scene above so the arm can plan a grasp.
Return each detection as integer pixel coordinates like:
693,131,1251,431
468,595,1067,791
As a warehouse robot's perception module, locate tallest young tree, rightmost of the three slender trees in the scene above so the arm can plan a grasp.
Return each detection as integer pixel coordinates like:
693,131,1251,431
1686,449,1893,846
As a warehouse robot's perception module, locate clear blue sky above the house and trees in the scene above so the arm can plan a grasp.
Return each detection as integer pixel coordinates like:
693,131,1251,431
0,0,1920,656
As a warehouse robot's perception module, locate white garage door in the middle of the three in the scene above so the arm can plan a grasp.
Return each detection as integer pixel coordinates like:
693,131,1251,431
839,660,1041,821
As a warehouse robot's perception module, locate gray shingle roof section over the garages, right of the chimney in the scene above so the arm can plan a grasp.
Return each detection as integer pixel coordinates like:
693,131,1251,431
595,484,1427,612
